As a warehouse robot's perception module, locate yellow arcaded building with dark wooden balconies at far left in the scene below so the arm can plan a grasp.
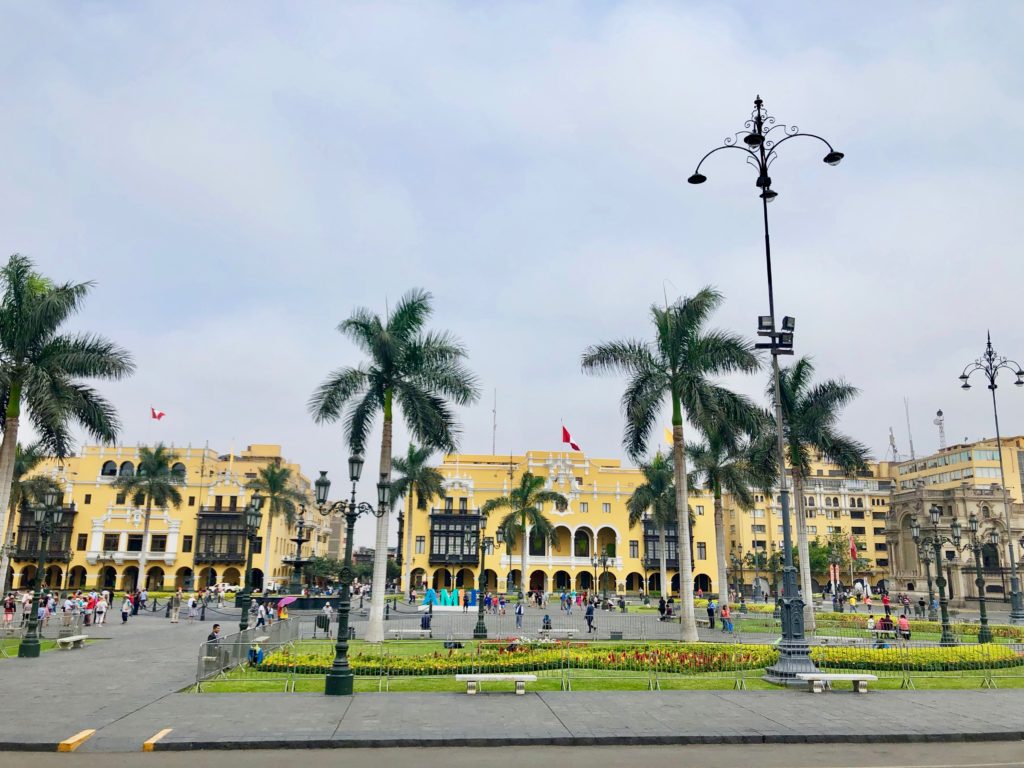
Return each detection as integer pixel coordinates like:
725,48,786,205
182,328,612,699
7,444,330,590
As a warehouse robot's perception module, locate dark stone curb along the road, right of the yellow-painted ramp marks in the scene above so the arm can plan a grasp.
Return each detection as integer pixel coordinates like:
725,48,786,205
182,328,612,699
149,731,1024,752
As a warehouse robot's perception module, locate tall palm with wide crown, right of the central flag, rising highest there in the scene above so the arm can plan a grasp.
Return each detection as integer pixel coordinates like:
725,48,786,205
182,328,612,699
583,287,760,642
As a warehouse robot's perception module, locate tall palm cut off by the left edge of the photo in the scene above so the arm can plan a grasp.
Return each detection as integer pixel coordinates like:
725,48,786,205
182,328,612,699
0,254,135,593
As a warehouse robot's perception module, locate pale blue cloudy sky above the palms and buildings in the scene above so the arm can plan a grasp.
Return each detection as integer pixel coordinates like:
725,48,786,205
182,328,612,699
0,0,1024,545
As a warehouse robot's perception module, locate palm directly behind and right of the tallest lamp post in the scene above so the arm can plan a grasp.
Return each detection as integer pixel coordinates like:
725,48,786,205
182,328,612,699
763,357,867,630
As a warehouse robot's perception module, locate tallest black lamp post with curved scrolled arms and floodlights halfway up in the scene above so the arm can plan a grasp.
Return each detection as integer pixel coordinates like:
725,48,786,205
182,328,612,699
687,96,843,683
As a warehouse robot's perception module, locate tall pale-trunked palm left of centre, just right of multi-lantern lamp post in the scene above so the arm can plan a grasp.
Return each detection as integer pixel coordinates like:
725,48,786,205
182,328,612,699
309,289,479,643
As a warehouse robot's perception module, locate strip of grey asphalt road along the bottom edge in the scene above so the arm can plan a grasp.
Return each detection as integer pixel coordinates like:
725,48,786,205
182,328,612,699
3,741,1024,768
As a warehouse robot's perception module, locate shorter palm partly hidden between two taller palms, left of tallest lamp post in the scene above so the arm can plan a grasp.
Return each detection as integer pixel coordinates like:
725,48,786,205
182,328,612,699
686,434,757,605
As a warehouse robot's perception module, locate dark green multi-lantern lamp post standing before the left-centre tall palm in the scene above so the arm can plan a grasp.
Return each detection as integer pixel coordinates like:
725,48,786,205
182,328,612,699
313,456,391,696
